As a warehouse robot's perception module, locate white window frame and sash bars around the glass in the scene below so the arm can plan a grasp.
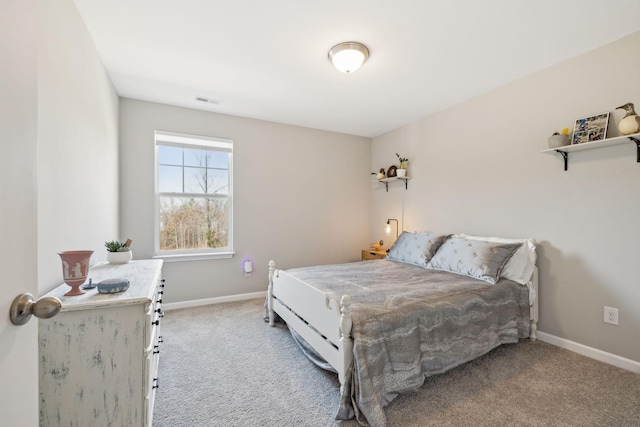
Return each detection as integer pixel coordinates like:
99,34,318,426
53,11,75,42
153,130,235,262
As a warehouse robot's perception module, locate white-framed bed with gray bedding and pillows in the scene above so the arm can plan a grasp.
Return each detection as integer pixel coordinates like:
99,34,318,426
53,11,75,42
266,232,538,427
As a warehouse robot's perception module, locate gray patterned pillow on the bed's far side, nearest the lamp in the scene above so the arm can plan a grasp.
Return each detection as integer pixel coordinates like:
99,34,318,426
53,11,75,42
387,231,449,267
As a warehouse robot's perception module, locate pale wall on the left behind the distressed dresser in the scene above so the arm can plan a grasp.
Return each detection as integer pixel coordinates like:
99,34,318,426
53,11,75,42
37,0,119,293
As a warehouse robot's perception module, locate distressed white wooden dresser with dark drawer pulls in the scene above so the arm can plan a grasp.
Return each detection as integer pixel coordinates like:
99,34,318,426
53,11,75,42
38,260,164,427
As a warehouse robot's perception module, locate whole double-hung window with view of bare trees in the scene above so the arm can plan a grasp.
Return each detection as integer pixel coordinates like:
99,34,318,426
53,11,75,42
155,131,233,260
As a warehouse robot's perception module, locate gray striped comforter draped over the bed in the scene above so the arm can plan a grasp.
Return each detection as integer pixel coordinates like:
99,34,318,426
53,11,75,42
287,260,529,426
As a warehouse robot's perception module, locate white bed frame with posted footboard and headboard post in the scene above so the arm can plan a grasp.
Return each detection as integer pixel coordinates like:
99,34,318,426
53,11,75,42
267,260,538,392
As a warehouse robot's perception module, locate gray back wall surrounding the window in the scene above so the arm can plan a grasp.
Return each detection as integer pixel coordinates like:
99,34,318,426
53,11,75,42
120,98,371,302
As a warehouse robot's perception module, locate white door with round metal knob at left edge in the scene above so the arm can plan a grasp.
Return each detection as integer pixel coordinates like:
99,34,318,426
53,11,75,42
0,0,39,427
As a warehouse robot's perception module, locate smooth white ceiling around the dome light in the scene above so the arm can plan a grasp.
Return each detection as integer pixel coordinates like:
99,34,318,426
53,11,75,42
75,0,640,137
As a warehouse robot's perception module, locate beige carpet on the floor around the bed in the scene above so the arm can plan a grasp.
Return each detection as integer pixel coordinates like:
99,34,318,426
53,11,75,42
153,299,640,427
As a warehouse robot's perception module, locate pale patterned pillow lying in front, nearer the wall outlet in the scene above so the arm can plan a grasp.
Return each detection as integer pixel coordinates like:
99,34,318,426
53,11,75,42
427,237,522,284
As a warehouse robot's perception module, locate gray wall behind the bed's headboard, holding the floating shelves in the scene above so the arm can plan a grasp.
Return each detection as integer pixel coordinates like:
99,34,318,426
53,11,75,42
371,33,640,361
